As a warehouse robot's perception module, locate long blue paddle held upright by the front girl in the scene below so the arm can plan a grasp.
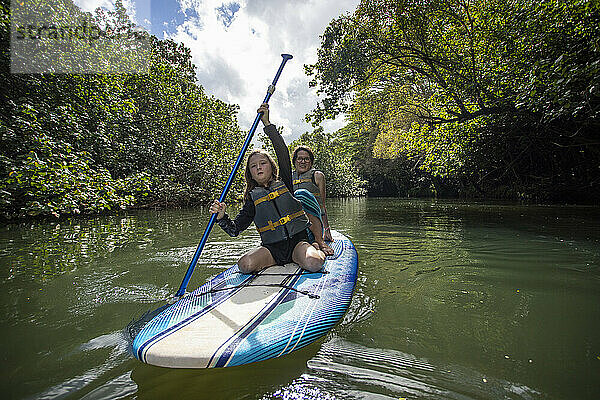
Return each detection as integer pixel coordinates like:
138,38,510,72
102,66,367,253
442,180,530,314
173,54,292,301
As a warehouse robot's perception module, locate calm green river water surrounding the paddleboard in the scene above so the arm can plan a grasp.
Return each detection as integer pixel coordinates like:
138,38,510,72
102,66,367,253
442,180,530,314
0,199,600,399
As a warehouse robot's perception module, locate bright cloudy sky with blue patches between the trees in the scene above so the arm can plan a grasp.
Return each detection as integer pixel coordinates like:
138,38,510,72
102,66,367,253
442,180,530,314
75,0,359,143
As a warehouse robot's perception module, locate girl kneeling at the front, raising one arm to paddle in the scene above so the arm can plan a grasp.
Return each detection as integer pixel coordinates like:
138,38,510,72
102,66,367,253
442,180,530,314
210,103,325,273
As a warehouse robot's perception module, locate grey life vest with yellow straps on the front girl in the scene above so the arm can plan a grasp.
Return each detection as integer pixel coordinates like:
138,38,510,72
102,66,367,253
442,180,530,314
250,180,309,243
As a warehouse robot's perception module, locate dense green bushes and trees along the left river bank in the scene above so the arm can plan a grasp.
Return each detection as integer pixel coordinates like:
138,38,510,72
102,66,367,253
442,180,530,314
0,3,242,218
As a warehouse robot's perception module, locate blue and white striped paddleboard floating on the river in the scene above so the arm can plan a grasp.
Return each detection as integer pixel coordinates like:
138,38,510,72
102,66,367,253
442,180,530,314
132,231,358,368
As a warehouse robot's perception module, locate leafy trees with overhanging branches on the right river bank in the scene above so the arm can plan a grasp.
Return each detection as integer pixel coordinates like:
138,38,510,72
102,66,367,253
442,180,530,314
307,0,600,202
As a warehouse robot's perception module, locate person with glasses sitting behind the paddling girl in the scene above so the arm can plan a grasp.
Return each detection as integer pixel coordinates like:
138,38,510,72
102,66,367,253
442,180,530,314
292,146,333,255
